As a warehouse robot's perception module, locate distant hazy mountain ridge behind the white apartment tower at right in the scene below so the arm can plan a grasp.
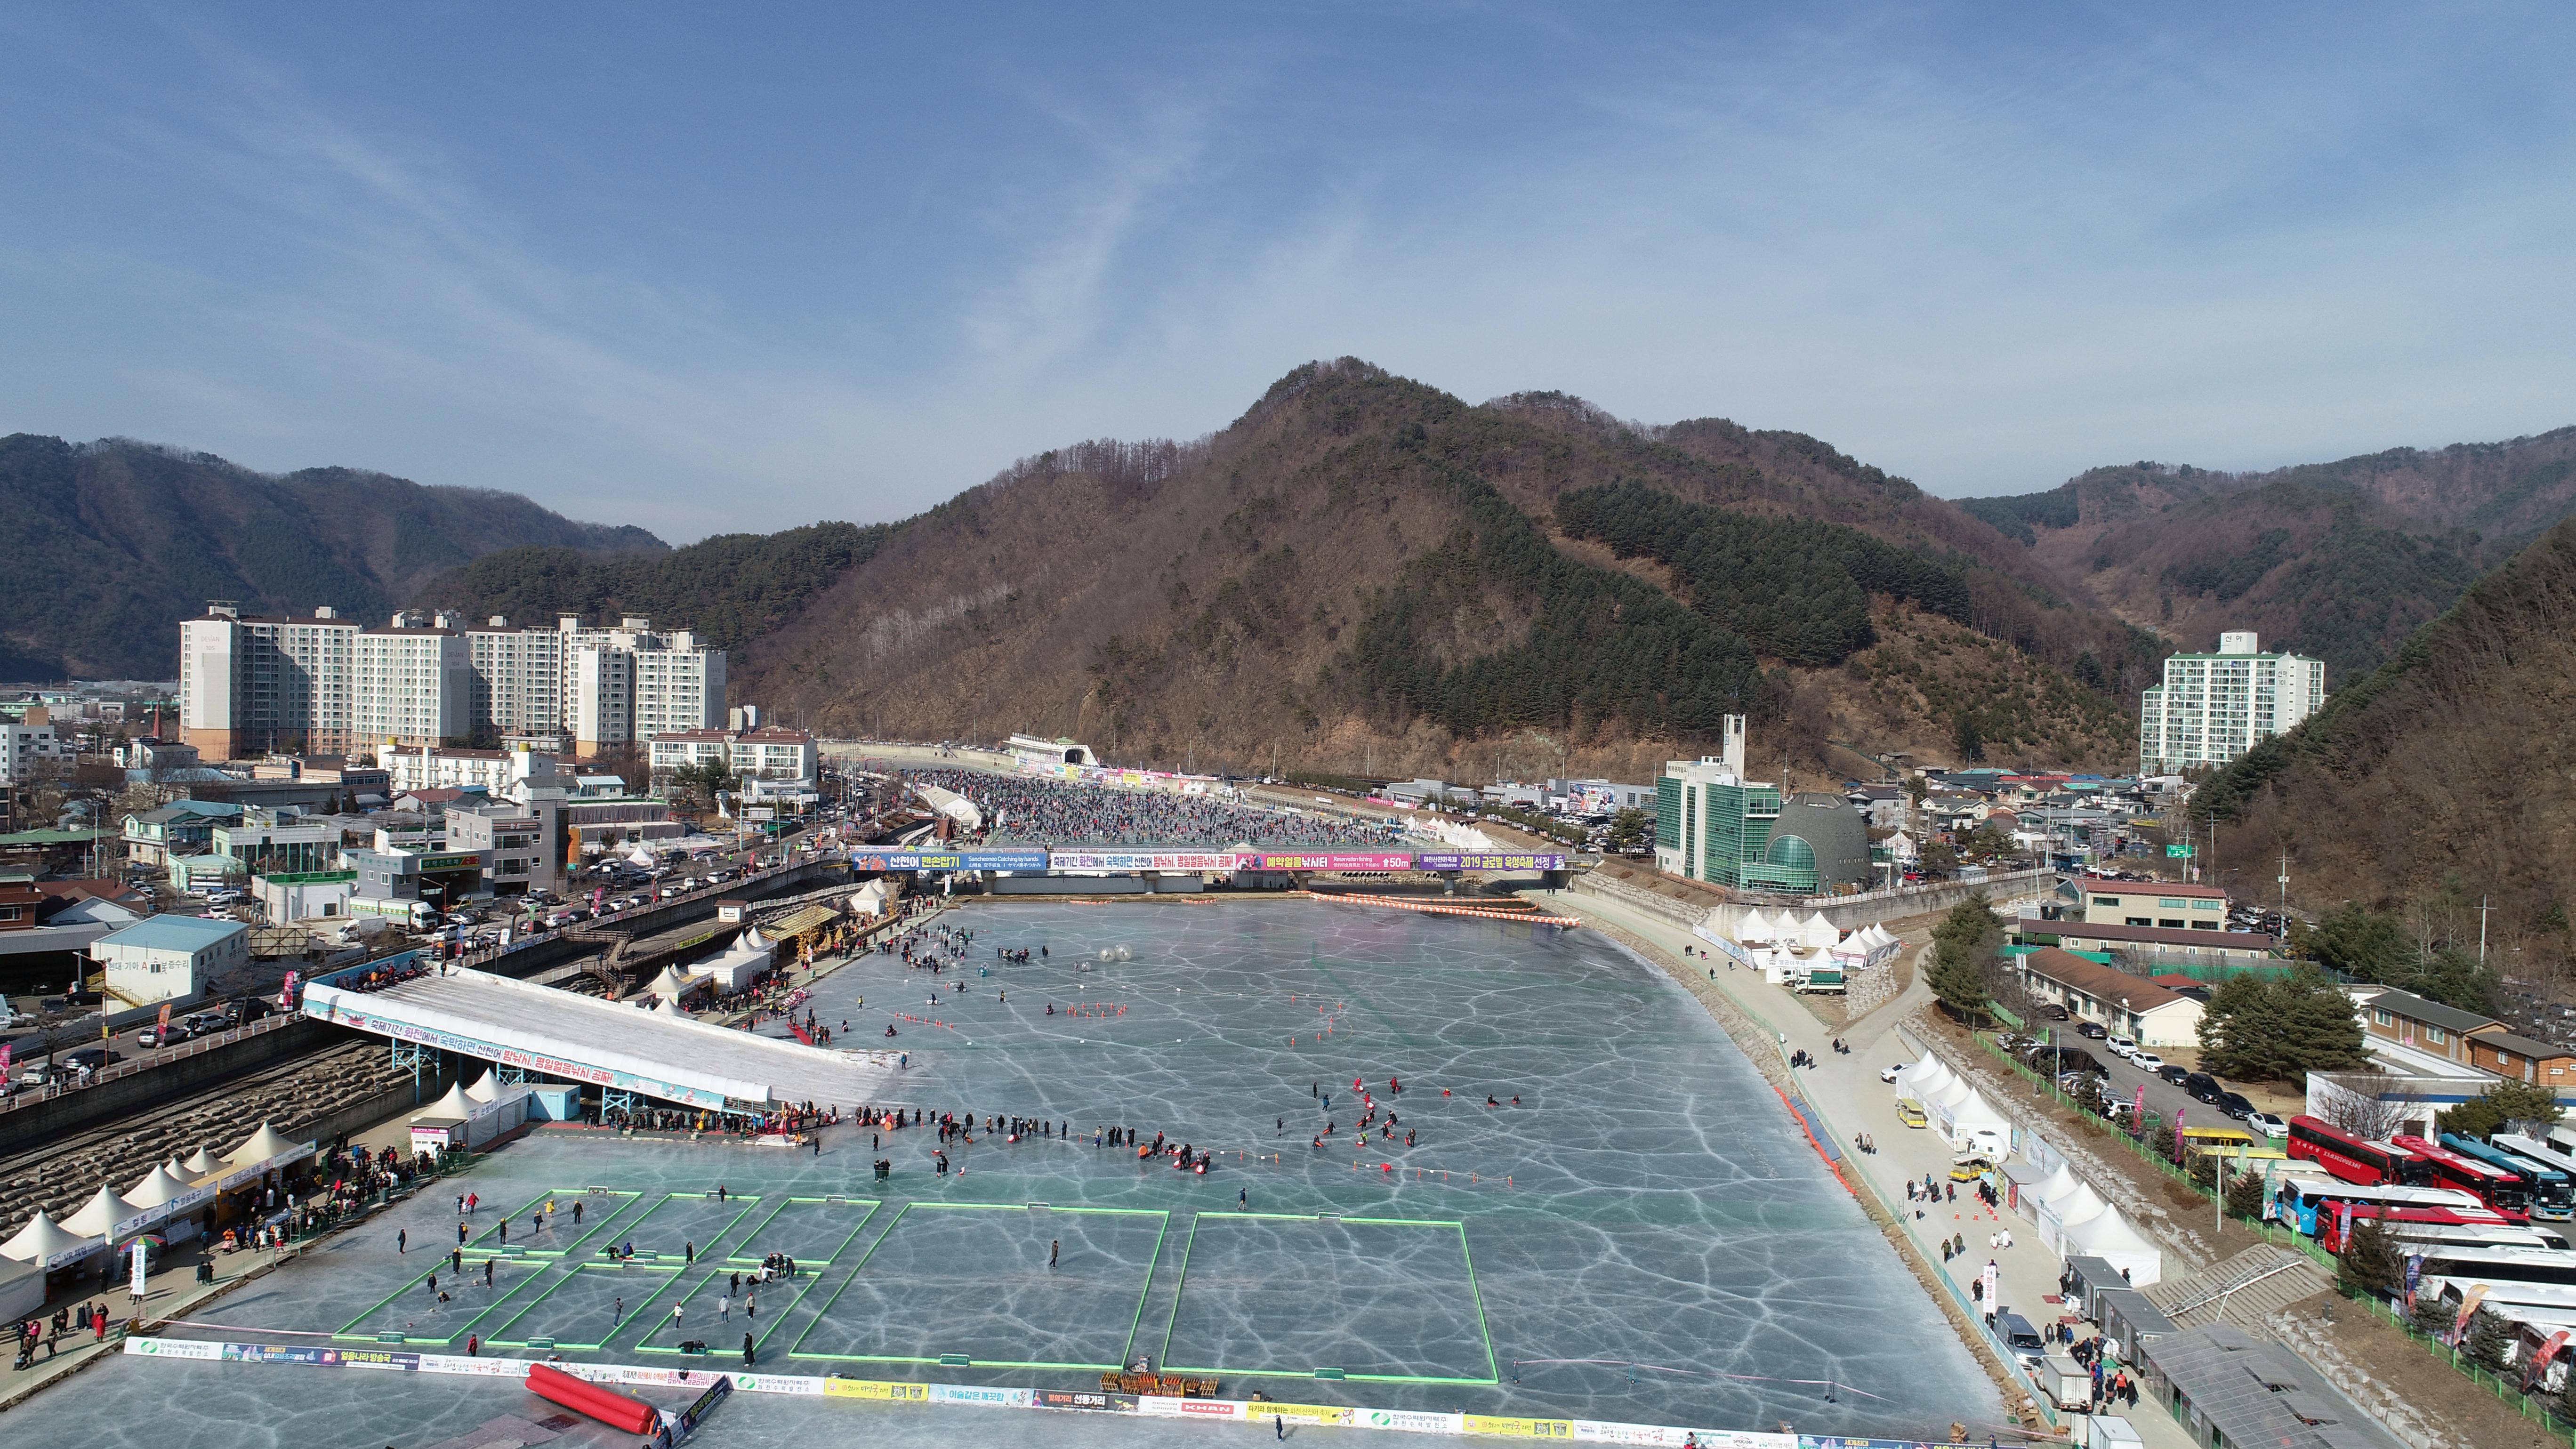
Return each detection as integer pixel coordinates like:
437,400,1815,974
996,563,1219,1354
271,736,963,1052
1960,428,2576,686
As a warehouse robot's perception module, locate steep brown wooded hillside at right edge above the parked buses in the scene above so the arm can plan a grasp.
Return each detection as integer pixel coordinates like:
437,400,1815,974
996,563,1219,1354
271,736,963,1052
2192,521,2576,985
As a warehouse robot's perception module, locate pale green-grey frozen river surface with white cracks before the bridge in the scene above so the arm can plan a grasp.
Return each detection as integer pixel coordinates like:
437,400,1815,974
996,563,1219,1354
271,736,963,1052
10,902,1999,1449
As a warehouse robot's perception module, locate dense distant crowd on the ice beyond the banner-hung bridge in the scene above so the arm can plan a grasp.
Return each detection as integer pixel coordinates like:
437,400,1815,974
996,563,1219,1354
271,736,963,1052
907,771,1399,848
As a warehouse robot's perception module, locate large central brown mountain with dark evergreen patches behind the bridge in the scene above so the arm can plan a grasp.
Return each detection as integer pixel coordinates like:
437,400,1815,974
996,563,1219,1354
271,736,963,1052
417,361,2151,779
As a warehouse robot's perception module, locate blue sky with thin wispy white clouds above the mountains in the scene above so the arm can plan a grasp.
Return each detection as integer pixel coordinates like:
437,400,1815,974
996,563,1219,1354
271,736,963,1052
0,2,2576,541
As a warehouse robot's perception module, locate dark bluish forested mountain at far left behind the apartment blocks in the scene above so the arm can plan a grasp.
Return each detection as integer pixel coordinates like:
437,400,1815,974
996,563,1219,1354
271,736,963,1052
0,433,665,681
